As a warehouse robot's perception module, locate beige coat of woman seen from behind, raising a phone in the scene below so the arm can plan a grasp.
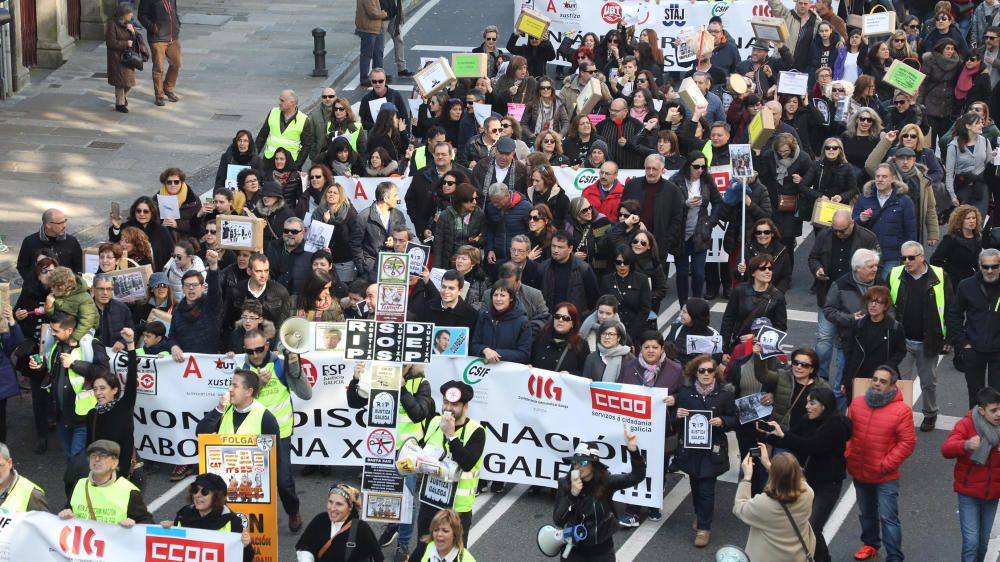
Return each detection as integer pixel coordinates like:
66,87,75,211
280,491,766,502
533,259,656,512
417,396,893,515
733,480,816,562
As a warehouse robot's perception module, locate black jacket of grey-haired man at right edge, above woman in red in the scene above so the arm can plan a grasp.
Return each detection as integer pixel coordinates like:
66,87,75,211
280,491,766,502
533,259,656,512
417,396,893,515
945,273,1000,353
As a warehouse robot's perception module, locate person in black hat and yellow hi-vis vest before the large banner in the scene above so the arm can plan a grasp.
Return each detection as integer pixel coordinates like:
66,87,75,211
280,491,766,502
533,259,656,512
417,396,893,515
410,378,486,560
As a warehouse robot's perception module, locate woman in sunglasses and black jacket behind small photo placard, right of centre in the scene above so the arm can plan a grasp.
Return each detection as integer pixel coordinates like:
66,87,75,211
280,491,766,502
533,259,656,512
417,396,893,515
720,254,788,353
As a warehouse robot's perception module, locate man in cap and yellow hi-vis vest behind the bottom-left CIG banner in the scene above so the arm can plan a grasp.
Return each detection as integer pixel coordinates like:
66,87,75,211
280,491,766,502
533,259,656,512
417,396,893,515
59,439,153,529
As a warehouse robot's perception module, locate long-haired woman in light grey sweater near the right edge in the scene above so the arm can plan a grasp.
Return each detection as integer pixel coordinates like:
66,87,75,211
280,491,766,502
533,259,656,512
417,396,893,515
944,112,995,216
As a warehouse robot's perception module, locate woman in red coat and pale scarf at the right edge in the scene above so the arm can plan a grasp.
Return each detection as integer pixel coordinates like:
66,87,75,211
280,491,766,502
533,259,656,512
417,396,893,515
941,386,1000,562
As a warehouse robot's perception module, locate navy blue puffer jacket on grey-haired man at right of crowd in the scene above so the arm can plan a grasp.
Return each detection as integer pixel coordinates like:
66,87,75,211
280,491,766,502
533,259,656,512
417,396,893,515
851,180,917,263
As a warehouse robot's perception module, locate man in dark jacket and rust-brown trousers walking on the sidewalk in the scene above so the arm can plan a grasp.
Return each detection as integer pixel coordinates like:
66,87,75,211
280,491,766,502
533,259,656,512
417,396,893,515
139,0,181,106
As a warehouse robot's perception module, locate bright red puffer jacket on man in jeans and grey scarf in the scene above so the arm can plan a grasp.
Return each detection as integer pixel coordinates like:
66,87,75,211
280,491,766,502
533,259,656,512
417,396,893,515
844,392,917,484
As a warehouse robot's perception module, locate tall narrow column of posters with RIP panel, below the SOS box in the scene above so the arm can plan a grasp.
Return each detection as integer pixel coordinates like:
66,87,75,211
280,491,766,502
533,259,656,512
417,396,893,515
361,363,413,523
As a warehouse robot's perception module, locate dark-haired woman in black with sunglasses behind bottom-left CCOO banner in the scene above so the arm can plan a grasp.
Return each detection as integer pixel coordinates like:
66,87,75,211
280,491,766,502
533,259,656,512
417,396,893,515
160,473,254,562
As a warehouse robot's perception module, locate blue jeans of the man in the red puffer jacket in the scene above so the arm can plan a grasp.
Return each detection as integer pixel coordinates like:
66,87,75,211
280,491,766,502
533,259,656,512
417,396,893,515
854,480,908,562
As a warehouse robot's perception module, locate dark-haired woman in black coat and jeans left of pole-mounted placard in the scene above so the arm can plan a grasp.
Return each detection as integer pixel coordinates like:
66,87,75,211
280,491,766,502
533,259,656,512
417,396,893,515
670,151,722,304
